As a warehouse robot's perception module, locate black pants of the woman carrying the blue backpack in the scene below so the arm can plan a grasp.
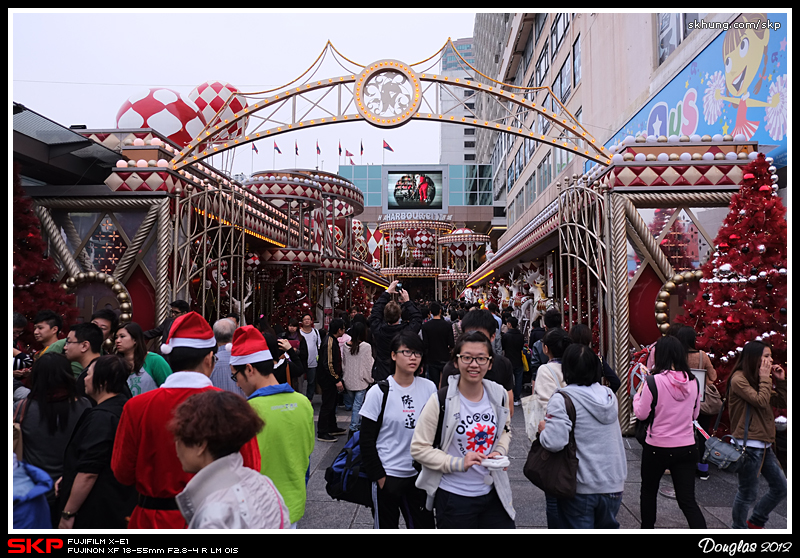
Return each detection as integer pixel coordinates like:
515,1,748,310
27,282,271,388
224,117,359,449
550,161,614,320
372,475,435,529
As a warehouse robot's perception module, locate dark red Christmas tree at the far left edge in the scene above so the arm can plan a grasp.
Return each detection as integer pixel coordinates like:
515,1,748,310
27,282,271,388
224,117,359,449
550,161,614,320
12,165,78,349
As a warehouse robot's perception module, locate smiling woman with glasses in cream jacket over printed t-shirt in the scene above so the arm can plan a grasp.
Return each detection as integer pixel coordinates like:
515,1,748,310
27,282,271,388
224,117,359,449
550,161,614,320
411,331,515,529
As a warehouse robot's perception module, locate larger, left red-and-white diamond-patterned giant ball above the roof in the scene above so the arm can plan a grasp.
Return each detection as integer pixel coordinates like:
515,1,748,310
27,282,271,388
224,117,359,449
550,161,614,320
117,87,205,147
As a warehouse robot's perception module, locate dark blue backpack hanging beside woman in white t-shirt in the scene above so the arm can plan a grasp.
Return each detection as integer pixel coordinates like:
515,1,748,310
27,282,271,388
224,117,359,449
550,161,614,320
325,380,389,508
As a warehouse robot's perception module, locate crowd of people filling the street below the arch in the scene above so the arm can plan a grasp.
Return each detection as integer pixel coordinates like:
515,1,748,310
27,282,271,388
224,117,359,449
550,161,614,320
12,281,787,529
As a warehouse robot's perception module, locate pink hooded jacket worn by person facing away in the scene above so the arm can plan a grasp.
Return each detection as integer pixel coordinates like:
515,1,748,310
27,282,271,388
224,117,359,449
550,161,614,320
633,370,700,448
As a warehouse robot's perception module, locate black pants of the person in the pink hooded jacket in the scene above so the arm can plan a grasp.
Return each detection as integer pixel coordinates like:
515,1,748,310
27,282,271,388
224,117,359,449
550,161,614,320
640,444,706,529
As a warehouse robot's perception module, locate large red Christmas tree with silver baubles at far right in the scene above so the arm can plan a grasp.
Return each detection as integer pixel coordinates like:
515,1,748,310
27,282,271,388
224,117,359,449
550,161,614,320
677,154,787,385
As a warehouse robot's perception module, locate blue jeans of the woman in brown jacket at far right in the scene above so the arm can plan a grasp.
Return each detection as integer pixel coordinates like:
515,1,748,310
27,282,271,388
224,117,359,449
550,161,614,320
732,447,786,529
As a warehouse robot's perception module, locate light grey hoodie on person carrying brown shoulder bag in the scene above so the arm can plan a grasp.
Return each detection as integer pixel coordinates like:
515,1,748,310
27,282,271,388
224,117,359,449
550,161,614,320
539,384,628,494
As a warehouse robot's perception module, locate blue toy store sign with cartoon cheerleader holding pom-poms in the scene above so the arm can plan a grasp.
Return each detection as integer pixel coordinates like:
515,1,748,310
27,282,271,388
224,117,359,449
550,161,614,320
606,14,789,167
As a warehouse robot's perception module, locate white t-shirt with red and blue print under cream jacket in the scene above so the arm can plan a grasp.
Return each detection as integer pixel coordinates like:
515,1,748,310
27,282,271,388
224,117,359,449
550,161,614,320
439,390,500,497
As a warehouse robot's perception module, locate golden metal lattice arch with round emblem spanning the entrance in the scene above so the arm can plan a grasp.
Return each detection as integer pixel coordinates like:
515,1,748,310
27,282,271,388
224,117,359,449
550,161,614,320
170,39,611,170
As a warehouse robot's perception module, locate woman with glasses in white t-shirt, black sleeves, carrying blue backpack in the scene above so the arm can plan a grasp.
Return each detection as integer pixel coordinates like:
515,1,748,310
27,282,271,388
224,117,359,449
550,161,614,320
359,330,436,529
